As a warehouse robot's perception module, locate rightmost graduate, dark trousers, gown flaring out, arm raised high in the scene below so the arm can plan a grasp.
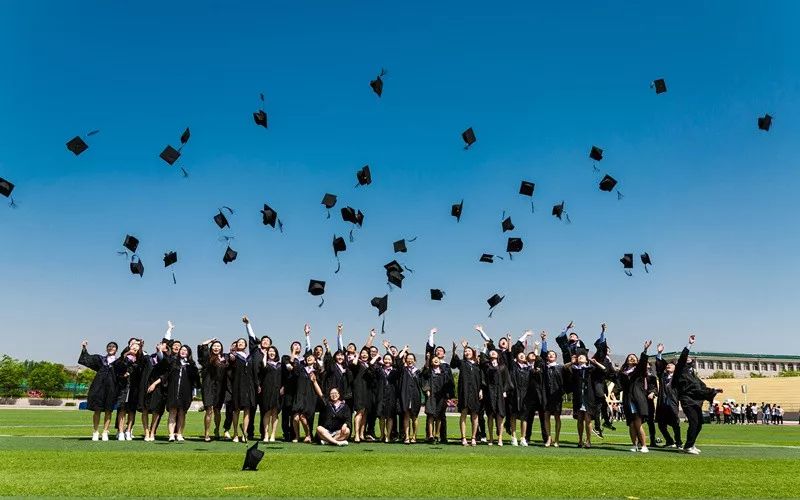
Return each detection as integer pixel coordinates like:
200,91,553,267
672,335,722,455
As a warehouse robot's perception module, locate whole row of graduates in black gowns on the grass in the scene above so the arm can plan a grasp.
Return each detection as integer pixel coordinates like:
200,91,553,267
79,316,722,454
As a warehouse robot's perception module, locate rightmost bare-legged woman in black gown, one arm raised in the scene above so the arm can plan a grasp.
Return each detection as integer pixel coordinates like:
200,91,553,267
619,340,655,453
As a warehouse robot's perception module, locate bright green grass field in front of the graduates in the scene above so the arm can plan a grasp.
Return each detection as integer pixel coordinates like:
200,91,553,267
0,410,800,498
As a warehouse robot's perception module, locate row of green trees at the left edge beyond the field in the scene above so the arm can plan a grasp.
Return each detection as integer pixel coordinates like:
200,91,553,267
0,354,94,398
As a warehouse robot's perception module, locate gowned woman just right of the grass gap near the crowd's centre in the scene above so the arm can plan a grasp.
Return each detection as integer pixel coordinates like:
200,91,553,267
450,340,483,446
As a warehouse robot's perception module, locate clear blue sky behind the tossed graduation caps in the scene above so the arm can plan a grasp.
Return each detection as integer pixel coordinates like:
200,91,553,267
0,1,800,363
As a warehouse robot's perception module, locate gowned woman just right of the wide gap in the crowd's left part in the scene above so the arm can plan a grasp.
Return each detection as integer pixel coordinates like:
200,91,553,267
197,339,228,441
